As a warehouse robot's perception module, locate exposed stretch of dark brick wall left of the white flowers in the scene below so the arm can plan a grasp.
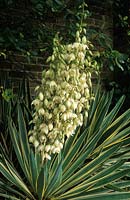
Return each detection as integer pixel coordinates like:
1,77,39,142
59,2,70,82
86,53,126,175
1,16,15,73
0,54,46,92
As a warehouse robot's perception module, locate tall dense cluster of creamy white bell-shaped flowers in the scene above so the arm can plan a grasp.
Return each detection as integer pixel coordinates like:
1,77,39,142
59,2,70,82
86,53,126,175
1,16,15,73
29,32,97,160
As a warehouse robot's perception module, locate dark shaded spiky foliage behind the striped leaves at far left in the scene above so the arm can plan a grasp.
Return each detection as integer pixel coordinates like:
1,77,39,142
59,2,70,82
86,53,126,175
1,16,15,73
0,73,31,158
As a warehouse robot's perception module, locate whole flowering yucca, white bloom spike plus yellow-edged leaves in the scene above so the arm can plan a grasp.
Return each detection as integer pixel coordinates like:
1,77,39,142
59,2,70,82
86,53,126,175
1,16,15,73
0,27,130,200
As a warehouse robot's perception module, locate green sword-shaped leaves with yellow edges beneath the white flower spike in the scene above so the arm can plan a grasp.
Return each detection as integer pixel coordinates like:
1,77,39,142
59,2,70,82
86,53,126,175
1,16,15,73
0,88,130,200
